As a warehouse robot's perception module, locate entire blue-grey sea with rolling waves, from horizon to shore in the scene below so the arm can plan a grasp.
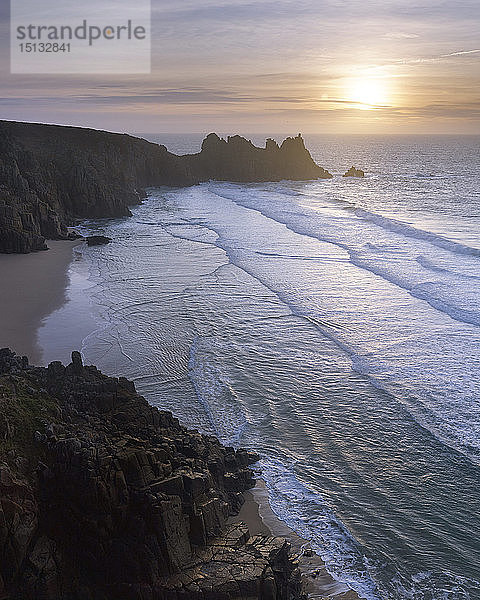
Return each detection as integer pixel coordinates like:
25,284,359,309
39,132,480,600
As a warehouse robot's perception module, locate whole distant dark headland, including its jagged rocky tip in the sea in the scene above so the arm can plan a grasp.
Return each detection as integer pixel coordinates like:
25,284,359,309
0,121,331,252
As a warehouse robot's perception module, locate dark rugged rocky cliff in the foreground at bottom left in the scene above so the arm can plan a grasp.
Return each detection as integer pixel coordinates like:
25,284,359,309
0,349,304,600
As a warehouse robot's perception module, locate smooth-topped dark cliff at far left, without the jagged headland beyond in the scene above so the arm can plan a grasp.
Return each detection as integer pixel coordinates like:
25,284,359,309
0,121,194,252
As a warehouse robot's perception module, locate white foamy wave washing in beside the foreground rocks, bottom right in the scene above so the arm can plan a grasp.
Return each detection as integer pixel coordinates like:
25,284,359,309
260,457,480,600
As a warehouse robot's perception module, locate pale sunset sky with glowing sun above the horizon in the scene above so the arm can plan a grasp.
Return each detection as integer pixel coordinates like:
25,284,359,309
0,0,480,134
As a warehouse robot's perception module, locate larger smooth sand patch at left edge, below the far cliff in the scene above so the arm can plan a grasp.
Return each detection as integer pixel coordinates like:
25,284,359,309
0,240,80,364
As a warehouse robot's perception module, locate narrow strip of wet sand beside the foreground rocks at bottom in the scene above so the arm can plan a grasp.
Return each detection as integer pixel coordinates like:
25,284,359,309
230,478,360,600
